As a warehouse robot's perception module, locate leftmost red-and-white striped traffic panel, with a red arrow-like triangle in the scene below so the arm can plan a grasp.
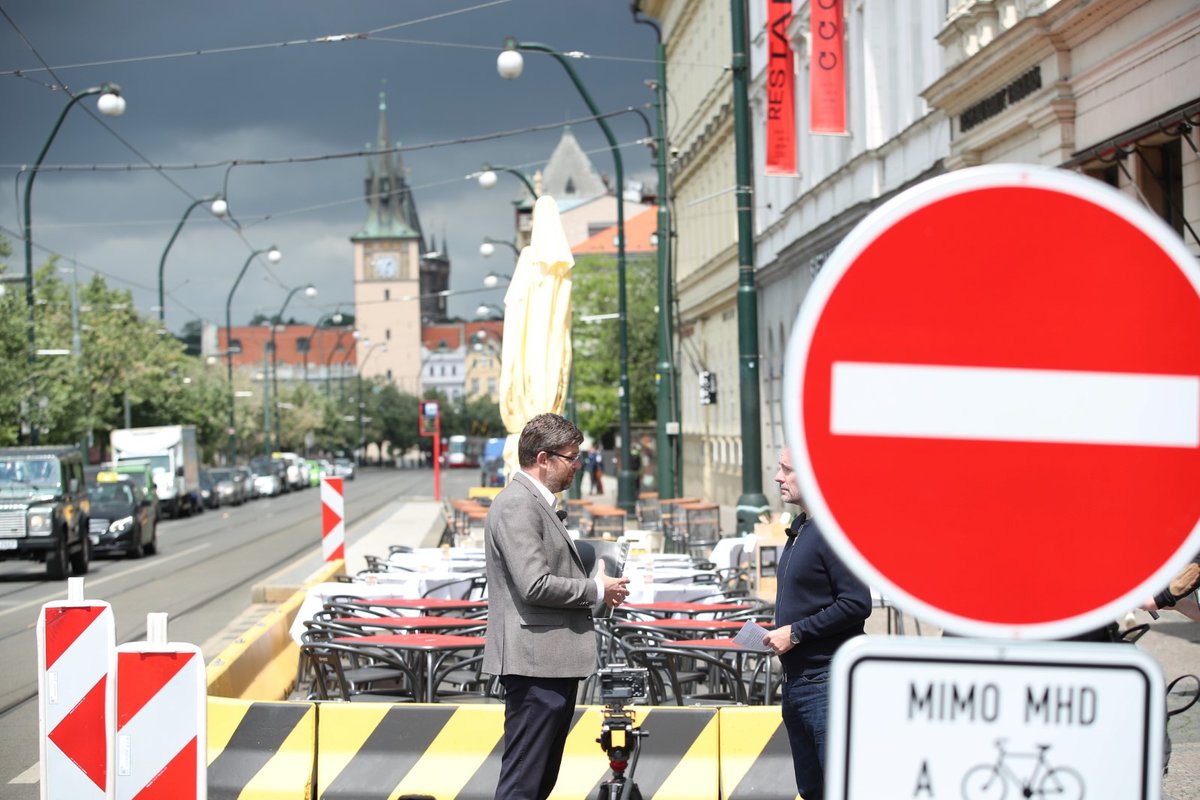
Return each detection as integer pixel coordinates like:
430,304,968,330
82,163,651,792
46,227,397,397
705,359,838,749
37,578,115,800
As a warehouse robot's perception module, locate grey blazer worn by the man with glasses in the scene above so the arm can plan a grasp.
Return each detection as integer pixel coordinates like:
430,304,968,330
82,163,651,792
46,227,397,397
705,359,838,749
484,473,599,678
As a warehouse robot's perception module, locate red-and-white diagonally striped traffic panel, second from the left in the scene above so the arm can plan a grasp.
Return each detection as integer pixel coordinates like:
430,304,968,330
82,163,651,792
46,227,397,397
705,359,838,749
113,614,208,800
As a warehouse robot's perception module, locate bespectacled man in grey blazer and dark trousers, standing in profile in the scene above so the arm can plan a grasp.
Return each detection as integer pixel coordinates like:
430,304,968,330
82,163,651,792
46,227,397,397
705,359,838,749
484,414,629,800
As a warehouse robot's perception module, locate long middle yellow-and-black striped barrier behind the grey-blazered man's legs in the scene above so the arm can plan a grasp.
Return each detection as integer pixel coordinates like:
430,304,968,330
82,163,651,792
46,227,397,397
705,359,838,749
317,703,715,800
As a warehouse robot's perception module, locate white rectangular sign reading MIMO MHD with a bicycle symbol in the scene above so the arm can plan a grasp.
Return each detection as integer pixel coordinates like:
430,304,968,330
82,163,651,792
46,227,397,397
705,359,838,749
826,637,1165,800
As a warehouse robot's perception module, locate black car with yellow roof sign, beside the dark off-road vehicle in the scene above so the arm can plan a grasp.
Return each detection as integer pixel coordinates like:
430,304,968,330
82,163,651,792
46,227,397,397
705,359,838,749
88,470,158,559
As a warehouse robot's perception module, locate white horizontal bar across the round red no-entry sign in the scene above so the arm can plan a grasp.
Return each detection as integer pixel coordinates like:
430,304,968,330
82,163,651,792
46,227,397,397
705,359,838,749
829,361,1200,447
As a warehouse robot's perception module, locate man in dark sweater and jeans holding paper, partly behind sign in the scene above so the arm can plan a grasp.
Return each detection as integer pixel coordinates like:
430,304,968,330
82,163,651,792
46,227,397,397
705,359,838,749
763,447,871,800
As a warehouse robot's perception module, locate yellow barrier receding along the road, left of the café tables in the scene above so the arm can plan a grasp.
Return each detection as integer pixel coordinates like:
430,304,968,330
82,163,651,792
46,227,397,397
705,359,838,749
208,560,343,700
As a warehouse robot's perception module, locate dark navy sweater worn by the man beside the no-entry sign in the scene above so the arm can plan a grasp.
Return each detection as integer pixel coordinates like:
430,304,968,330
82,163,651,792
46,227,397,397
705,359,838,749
775,513,871,676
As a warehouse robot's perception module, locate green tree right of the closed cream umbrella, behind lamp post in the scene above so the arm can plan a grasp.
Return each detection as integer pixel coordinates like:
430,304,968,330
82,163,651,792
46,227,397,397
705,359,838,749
571,253,658,438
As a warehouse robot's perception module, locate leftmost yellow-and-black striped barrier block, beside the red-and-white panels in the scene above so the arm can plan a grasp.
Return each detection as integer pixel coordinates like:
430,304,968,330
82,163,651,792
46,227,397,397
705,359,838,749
208,697,317,800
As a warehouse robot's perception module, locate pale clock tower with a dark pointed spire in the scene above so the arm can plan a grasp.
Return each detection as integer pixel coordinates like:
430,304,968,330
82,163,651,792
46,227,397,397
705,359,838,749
350,92,439,393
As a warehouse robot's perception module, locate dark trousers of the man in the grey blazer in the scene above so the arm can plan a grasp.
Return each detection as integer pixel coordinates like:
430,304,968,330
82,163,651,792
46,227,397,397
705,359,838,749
496,675,580,800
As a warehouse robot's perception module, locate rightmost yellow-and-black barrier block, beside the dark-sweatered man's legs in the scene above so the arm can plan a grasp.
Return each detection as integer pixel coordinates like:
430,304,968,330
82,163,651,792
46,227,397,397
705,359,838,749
719,705,799,800
